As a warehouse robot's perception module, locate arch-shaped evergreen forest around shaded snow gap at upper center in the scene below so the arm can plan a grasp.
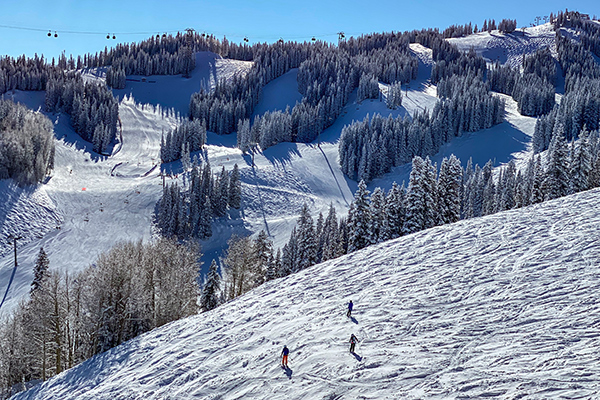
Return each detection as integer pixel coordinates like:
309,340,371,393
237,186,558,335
190,33,418,148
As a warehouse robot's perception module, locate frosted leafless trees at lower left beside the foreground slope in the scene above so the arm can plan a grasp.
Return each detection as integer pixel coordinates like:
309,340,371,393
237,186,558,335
0,239,200,395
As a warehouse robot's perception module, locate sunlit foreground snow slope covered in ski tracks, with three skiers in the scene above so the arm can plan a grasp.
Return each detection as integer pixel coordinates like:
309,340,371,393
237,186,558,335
15,190,600,400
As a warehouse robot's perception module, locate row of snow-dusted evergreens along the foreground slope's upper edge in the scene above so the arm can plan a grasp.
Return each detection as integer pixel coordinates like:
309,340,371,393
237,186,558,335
264,123,600,277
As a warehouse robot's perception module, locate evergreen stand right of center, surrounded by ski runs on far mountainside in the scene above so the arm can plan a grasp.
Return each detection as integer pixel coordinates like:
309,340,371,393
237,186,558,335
338,75,504,182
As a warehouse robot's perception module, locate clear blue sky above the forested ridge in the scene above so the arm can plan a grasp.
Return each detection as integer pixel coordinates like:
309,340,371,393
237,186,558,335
0,0,600,57
